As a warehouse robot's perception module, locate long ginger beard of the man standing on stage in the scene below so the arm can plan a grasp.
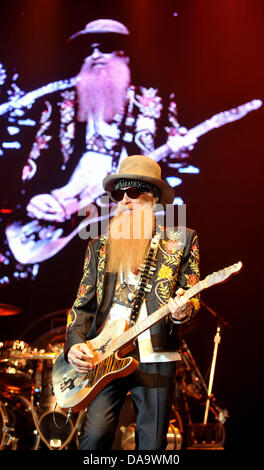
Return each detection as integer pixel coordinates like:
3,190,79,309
106,204,155,275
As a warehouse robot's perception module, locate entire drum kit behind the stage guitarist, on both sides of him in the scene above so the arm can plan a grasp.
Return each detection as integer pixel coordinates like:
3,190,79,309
0,304,228,450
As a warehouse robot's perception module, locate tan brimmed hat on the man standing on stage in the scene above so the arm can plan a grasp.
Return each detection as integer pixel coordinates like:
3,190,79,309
103,155,174,206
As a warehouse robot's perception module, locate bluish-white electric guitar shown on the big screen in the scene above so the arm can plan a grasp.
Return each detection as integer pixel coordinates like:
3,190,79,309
6,100,262,264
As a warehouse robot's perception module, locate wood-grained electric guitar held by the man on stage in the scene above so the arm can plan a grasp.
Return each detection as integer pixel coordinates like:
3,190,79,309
52,261,243,411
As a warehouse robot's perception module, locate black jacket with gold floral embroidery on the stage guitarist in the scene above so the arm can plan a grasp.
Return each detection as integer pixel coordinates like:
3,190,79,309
65,228,200,353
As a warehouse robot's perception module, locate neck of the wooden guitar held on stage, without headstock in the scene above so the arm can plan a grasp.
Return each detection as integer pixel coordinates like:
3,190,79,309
111,281,206,351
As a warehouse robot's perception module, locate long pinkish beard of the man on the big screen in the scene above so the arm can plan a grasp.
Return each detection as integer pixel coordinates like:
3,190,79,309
76,53,130,122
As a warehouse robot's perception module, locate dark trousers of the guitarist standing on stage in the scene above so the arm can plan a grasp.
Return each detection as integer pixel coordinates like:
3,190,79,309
80,362,176,451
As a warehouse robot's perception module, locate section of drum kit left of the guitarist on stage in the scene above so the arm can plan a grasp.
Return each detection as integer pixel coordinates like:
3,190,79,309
0,304,84,450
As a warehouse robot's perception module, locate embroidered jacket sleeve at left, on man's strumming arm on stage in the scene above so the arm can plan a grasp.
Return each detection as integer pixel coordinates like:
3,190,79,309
64,241,97,354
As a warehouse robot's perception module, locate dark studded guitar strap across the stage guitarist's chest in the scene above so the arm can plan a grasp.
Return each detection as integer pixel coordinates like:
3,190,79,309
129,233,160,326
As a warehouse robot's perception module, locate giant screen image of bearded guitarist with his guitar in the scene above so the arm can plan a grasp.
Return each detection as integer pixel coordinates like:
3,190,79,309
0,19,256,284
